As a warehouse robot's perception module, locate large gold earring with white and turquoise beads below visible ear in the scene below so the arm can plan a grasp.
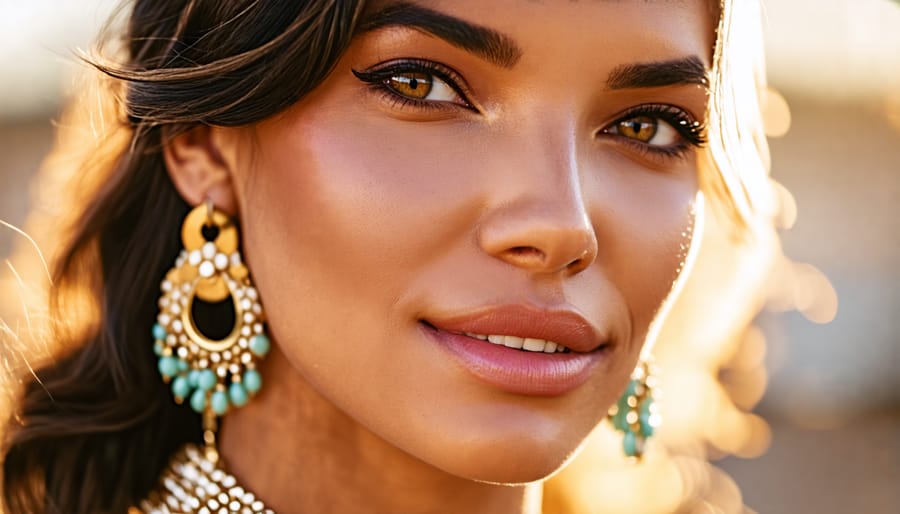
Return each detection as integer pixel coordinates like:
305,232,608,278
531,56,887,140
153,201,271,462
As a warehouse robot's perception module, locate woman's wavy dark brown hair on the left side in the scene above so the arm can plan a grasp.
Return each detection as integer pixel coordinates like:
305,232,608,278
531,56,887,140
2,0,363,514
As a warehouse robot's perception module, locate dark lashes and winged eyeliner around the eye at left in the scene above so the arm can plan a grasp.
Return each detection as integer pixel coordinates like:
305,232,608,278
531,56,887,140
351,59,477,111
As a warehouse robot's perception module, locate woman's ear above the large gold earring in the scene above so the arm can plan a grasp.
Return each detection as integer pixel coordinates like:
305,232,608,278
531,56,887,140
163,125,237,216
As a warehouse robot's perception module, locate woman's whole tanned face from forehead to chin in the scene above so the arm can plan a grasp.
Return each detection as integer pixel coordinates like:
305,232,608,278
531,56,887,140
229,0,714,482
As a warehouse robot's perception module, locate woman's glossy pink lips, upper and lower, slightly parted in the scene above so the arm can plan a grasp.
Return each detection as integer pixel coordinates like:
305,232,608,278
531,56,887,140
422,306,608,396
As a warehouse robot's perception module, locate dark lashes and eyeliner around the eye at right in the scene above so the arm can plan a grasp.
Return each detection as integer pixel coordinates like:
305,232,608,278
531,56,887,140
599,104,706,158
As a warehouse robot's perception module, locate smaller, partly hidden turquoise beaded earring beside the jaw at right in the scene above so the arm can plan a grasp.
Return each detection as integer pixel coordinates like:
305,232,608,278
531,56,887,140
607,360,661,460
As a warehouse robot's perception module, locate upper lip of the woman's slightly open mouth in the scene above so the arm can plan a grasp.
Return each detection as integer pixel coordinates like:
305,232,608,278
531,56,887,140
423,305,607,352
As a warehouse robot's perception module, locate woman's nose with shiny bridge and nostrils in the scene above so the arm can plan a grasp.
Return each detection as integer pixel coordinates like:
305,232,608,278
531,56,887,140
478,138,598,275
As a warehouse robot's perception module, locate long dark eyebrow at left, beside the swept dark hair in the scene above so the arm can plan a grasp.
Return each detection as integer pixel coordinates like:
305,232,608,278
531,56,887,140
357,2,522,68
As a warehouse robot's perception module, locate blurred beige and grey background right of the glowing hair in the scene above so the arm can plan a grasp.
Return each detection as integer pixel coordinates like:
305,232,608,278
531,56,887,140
720,0,900,513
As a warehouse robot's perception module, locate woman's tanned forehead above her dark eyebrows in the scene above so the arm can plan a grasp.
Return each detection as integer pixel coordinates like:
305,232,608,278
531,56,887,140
367,0,718,67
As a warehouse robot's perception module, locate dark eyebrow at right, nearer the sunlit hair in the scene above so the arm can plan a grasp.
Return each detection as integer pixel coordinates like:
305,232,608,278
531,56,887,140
606,55,709,89
